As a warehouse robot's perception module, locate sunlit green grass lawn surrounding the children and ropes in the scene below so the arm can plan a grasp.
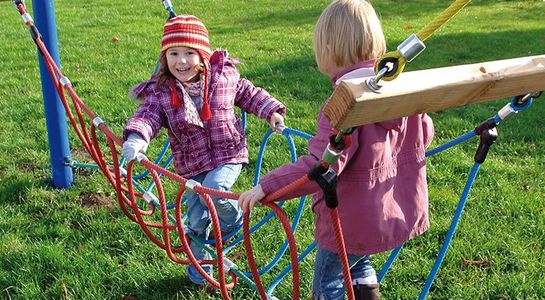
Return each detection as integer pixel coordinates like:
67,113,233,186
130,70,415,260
0,0,545,299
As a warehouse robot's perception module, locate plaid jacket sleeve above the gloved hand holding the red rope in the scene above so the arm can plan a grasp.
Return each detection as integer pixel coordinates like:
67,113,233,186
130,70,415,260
123,94,164,143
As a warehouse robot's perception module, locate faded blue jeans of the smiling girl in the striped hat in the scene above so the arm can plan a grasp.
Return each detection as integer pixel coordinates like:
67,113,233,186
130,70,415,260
186,164,242,285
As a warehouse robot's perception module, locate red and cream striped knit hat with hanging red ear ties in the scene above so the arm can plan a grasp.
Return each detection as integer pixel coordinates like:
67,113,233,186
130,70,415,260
161,15,212,121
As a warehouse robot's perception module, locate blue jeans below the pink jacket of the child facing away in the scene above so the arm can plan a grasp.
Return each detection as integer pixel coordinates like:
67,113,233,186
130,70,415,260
312,246,376,300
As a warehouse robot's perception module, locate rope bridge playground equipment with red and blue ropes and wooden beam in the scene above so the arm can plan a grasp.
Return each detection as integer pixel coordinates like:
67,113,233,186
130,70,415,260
14,1,545,299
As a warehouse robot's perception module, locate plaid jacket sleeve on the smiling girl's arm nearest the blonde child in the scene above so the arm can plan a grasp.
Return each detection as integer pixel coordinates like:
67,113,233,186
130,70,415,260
235,78,286,120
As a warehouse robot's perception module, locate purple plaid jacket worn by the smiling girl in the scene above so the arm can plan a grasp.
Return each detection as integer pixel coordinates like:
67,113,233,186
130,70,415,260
123,50,286,178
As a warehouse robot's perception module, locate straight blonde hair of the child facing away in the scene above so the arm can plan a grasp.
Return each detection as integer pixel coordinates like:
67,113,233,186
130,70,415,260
313,0,386,67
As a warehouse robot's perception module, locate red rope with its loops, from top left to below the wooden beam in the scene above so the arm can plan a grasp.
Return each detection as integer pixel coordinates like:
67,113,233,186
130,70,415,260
13,4,354,299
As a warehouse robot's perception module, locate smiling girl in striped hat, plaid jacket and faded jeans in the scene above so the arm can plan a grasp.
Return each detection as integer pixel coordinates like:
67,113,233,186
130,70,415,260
122,15,285,285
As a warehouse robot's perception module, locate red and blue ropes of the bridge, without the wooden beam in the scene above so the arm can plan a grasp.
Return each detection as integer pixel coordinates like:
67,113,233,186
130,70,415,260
10,1,545,299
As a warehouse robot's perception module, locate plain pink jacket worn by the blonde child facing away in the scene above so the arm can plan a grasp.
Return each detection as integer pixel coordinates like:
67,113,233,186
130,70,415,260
261,63,434,255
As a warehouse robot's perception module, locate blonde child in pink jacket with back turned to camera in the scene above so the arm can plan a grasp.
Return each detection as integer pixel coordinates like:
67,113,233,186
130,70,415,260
239,0,434,300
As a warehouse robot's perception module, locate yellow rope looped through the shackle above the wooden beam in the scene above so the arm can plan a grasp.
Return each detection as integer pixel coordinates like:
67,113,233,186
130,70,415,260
375,0,471,81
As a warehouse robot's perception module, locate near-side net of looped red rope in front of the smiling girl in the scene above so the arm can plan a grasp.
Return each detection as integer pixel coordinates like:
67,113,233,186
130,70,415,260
16,3,310,299
